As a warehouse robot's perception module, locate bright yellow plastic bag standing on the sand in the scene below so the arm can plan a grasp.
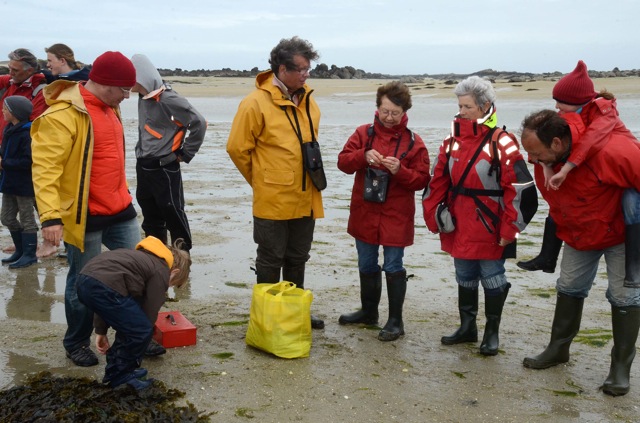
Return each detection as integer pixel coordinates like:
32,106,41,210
245,282,313,358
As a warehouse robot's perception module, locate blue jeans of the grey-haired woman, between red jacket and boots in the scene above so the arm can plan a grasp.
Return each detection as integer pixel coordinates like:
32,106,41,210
453,258,507,293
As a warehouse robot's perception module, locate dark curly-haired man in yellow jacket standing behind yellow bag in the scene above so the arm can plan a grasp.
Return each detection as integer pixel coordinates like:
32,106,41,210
227,37,324,329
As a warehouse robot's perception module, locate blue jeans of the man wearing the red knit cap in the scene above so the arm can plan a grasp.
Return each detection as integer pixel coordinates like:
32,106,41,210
62,218,140,352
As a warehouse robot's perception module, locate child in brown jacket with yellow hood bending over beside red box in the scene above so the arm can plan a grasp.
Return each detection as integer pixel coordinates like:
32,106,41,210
77,236,191,390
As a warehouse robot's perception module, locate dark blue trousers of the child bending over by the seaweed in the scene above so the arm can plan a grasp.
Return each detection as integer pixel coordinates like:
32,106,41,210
77,275,153,385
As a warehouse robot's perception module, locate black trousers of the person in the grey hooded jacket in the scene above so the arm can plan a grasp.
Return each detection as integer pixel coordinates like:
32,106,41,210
136,161,191,251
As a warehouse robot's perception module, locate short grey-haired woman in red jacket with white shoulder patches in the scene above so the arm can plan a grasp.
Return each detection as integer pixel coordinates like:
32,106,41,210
423,76,538,355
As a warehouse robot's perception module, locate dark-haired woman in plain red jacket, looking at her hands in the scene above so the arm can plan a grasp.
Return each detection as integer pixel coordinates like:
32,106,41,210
338,81,430,341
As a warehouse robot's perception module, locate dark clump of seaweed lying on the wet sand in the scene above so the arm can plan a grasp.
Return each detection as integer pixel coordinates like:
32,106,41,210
0,372,213,423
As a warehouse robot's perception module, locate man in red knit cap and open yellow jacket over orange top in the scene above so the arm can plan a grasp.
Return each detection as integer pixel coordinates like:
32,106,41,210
31,51,140,366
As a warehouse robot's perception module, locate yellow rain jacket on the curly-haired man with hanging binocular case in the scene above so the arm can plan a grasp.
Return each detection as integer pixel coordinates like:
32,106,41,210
227,71,324,220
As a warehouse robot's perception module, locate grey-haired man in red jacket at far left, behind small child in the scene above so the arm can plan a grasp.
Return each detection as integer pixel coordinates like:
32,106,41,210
0,48,47,134
